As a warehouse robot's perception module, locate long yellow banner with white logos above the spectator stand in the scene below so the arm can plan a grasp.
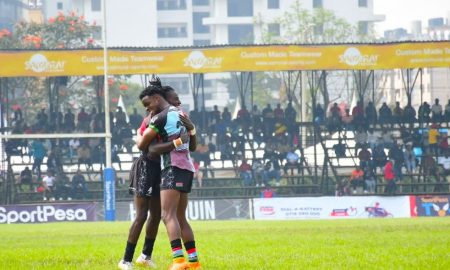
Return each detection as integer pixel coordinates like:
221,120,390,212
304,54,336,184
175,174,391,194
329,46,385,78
0,41,450,77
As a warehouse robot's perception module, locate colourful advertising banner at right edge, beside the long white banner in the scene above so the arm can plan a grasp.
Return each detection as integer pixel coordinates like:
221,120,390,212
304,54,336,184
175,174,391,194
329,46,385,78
411,195,450,217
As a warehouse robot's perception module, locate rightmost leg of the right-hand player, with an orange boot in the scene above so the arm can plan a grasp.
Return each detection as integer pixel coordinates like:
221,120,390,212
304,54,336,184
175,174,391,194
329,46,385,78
177,193,201,269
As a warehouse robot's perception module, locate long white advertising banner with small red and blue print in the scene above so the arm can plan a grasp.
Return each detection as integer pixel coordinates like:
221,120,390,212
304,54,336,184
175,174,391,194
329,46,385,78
253,196,411,220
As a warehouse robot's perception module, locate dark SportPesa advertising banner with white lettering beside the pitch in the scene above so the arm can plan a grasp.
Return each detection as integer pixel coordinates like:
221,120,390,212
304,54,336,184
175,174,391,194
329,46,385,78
0,203,96,224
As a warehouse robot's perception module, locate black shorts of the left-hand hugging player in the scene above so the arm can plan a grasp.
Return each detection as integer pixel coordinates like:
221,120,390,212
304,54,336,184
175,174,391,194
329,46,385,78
129,156,161,198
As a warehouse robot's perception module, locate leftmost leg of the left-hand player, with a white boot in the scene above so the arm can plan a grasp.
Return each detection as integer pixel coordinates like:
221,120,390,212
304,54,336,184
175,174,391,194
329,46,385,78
118,195,148,269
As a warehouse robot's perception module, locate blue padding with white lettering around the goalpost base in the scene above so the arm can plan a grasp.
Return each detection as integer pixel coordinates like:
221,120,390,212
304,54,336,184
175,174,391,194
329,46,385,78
103,168,116,221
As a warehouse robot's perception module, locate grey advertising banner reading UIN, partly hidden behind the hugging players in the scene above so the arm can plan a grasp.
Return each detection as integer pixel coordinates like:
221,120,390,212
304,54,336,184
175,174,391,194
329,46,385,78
121,199,251,220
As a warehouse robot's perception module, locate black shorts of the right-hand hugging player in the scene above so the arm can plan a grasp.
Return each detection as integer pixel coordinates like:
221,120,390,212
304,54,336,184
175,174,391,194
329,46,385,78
161,166,194,193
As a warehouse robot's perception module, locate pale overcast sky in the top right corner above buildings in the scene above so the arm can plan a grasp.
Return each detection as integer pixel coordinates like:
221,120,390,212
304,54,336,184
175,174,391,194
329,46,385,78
374,0,450,35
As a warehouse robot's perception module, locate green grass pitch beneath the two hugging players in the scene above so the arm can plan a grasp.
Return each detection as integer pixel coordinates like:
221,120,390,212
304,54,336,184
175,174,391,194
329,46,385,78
0,218,450,269
